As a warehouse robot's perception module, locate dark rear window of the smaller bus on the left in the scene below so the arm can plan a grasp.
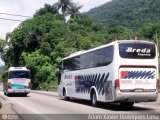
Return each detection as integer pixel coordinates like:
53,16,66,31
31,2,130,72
9,71,29,79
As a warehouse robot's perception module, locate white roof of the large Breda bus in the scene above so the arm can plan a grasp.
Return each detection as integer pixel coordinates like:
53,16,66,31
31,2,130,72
62,40,154,60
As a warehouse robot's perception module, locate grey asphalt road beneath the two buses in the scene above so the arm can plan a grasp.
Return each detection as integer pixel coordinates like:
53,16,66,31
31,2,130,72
0,91,160,120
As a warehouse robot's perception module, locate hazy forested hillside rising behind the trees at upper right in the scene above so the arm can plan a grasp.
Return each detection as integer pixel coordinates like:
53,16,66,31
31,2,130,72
87,0,160,31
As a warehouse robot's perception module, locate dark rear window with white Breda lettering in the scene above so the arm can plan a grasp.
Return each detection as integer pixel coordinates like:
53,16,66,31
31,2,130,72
119,43,156,59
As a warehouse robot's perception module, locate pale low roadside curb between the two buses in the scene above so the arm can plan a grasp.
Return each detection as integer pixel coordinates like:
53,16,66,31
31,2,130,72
31,90,58,97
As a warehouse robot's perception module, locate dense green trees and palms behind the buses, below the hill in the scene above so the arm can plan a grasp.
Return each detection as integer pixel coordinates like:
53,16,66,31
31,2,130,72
0,0,160,90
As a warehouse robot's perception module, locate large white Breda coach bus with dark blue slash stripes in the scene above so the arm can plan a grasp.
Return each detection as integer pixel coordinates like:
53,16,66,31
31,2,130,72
57,40,158,107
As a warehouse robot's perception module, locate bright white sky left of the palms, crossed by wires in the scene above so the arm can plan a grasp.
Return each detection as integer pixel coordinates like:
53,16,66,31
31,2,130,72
0,0,56,39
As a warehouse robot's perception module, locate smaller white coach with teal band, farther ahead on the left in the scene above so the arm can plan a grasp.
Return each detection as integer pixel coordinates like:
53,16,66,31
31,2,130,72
2,67,31,96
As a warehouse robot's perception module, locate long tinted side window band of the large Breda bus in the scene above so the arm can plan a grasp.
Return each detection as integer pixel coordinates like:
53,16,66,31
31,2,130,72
63,46,114,71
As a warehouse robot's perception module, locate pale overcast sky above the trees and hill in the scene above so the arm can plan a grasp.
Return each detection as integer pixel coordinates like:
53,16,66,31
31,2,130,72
0,0,110,64
